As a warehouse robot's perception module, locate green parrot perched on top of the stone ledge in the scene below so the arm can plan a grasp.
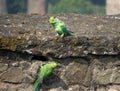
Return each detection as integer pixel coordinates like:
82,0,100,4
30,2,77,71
49,16,77,37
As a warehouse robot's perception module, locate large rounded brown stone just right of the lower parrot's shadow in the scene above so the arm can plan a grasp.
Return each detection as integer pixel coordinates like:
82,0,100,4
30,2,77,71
65,59,88,84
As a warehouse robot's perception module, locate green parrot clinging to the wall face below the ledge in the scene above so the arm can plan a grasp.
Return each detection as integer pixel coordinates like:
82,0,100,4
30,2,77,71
34,62,58,91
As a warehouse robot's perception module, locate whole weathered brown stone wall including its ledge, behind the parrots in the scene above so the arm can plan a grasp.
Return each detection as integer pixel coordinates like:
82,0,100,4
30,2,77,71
0,14,120,91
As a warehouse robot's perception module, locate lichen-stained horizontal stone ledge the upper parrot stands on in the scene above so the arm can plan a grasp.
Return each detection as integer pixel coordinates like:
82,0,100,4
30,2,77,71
0,14,120,58
